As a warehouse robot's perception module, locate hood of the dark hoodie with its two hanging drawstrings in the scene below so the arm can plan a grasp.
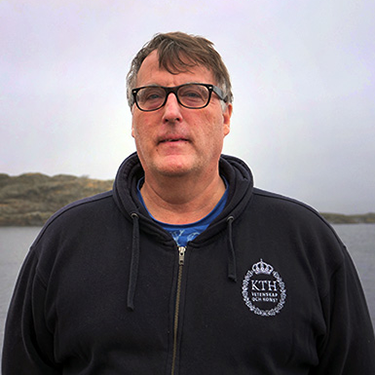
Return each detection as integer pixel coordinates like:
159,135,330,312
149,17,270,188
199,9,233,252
113,153,253,310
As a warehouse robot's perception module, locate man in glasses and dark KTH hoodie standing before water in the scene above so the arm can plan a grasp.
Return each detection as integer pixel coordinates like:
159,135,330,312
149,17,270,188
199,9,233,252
3,33,375,375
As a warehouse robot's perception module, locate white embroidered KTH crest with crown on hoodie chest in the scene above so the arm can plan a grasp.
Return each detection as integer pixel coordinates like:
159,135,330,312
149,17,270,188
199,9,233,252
242,259,286,316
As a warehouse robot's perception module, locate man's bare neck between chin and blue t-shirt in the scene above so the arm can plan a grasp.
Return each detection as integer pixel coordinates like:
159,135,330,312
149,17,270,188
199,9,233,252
141,174,225,224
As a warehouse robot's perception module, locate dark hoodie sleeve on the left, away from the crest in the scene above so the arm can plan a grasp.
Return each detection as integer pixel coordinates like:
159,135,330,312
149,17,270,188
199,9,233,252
2,249,62,375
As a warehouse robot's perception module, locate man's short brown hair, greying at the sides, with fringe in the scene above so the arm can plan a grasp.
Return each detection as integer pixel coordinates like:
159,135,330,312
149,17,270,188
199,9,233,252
126,32,233,107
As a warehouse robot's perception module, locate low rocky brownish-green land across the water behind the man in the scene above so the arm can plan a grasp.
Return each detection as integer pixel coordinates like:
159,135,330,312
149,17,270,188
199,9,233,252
0,173,375,226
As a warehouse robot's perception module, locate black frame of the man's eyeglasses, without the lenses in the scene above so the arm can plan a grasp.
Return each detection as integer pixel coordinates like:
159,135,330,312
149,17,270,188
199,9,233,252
132,82,227,112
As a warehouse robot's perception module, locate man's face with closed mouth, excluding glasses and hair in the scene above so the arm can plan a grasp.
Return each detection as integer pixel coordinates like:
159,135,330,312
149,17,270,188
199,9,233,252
132,51,232,182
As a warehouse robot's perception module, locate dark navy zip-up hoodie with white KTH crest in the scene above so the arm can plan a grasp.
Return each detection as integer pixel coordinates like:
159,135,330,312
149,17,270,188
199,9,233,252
3,154,375,375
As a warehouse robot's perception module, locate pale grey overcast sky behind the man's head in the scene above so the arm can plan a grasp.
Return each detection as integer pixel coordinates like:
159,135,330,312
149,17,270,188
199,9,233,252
0,0,375,213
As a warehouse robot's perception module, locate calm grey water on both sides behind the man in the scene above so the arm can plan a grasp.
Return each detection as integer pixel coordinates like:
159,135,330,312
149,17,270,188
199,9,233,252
0,224,375,356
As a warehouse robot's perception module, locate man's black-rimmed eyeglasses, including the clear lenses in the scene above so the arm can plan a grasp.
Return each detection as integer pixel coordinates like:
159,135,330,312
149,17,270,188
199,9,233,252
132,83,226,112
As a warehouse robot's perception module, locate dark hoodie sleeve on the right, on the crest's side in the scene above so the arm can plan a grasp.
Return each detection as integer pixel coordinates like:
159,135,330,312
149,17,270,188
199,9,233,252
310,249,375,375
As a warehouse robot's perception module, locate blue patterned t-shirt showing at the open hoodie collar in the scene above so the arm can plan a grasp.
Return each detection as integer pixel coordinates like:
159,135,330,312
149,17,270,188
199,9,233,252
137,178,228,246
